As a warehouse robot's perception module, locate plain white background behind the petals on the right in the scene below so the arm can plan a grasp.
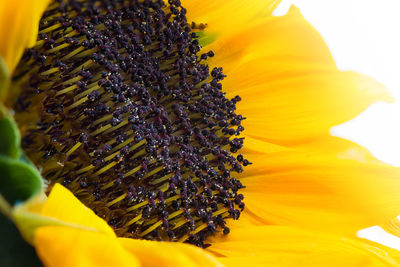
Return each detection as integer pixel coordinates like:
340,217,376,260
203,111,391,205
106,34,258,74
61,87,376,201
275,0,400,249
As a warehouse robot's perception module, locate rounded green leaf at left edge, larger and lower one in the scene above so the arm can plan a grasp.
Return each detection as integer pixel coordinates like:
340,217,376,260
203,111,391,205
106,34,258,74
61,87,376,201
0,155,42,205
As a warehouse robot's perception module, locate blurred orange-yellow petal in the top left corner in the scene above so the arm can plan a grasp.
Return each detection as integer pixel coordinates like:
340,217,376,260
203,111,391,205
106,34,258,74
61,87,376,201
0,0,50,73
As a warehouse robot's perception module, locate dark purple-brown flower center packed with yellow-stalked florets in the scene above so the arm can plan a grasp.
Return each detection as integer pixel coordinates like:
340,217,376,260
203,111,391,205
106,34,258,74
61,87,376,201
14,0,250,246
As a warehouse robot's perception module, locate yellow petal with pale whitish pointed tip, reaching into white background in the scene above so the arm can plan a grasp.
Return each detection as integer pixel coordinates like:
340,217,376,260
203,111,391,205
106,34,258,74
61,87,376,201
235,72,387,145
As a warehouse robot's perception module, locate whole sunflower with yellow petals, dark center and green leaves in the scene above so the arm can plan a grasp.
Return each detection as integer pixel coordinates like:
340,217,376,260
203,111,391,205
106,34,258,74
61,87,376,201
0,0,400,266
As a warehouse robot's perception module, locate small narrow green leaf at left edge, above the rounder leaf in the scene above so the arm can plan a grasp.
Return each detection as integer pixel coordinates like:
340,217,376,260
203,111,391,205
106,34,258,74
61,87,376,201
0,117,21,159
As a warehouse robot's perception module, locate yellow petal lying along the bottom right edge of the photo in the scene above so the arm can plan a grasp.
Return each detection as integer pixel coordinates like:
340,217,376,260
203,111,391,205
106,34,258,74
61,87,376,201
208,226,400,267
